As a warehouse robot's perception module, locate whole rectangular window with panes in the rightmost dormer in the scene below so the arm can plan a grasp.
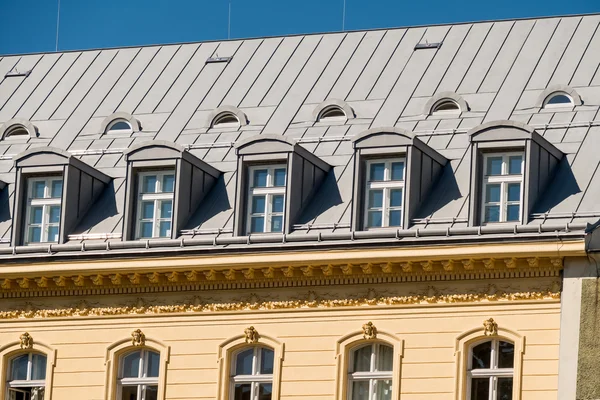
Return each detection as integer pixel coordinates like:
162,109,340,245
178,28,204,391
482,152,523,224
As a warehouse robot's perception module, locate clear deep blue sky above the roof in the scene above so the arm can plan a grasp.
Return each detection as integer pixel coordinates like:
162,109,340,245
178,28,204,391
0,0,600,54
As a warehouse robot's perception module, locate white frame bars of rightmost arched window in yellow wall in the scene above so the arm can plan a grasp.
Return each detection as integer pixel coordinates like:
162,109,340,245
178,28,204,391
467,339,516,400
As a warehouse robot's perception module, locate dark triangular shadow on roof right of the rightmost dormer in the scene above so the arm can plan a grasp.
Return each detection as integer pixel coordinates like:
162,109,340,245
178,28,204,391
532,157,581,214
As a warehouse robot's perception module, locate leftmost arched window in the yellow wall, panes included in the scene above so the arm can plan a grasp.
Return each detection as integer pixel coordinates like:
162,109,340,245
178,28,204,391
6,352,47,400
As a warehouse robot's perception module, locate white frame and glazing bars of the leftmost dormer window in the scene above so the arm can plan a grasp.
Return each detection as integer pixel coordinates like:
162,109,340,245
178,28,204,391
23,175,65,244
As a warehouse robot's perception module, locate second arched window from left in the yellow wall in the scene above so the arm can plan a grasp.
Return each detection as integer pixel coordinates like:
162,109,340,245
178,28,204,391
117,349,160,400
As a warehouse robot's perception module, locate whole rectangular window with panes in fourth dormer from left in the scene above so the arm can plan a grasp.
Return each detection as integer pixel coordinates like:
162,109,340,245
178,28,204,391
365,158,405,229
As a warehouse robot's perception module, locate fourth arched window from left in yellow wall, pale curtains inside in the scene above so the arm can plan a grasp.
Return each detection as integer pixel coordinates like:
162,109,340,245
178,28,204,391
347,343,394,400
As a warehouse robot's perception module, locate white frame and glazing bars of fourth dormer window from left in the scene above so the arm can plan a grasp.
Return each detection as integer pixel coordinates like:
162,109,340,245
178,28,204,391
363,157,406,230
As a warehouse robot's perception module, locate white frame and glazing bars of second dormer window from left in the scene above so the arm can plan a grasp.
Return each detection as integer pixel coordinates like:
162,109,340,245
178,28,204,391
135,170,177,239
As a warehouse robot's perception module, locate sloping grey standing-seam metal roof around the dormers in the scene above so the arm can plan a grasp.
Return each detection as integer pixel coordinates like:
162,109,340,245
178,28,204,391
0,14,600,256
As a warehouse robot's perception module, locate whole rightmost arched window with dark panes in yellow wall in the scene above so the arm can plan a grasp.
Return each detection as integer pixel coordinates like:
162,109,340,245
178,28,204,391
467,340,515,400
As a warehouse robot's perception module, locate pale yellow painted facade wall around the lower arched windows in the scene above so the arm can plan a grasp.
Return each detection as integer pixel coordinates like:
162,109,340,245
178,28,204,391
0,294,560,400
